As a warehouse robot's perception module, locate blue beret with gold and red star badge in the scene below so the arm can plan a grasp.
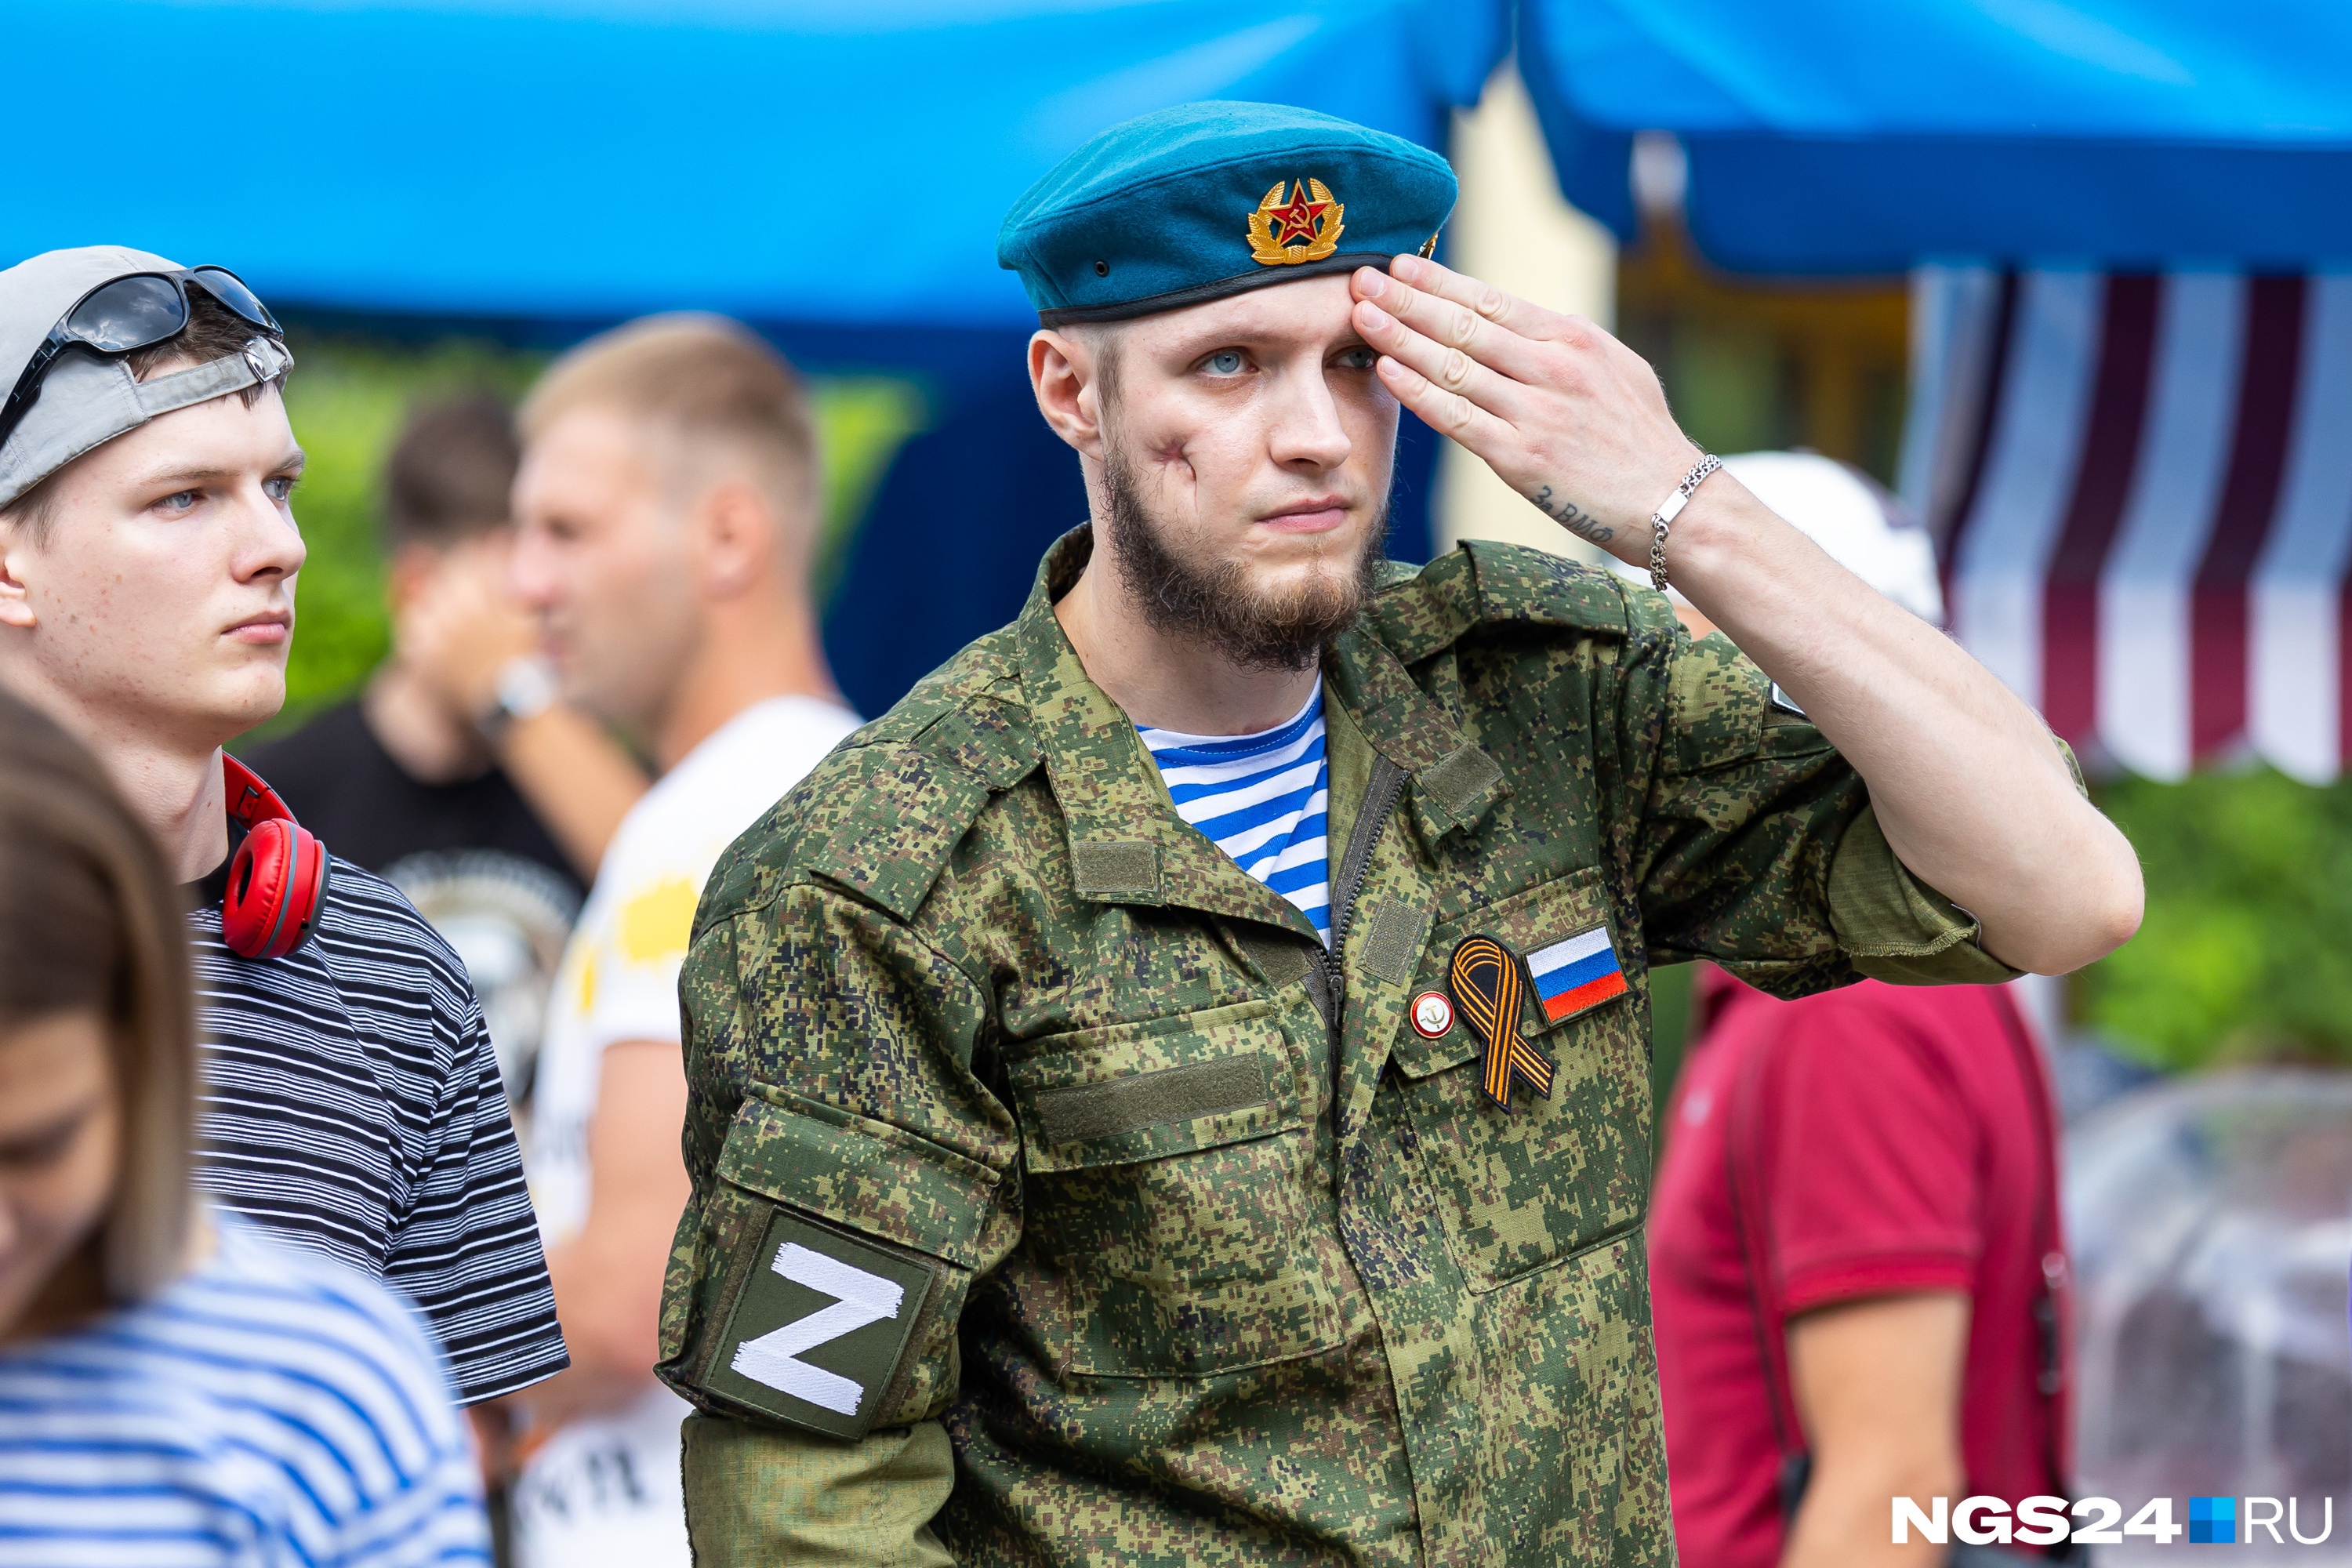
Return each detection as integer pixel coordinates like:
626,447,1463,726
997,103,1454,327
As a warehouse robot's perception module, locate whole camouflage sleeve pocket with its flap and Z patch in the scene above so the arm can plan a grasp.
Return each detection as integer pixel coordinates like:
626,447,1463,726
691,1088,997,1439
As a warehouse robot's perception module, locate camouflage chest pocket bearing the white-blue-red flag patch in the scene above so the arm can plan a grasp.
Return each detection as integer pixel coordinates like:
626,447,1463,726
1392,869,1649,1290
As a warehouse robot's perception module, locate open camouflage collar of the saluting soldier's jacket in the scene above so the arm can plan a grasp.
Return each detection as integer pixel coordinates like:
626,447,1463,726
1016,524,1505,938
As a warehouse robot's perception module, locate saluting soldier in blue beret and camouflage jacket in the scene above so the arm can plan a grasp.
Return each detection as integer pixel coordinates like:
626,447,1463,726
661,103,2140,1563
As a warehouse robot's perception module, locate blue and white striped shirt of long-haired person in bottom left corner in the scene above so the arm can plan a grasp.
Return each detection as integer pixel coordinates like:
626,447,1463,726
0,1218,489,1568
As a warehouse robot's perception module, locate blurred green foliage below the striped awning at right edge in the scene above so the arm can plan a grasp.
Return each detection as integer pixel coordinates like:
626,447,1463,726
2077,769,2352,1069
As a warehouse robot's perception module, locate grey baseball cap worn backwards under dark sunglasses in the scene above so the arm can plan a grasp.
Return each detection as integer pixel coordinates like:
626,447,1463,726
0,245,294,508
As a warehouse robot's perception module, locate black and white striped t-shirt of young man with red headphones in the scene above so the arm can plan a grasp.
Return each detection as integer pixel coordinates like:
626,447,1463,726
188,860,567,1403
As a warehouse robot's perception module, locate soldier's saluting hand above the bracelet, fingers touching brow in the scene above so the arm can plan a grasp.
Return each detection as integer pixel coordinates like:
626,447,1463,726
1350,256,1698,567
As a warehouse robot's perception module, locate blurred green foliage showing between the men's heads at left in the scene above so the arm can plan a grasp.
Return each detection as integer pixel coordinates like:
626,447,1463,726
261,336,929,734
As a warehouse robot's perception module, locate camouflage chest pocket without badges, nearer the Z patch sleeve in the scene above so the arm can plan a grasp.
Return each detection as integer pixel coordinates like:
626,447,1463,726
1009,1001,1338,1377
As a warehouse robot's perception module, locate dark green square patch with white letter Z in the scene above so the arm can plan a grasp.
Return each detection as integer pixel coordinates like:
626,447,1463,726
703,1208,931,1439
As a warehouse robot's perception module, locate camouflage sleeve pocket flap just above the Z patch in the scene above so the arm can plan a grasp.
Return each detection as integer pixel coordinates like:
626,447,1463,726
717,1088,997,1269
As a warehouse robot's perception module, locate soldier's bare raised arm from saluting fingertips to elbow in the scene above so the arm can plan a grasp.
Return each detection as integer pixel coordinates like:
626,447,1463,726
1355,256,2143,973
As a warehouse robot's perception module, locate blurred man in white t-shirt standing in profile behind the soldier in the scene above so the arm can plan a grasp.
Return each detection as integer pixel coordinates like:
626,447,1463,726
496,315,858,1568
